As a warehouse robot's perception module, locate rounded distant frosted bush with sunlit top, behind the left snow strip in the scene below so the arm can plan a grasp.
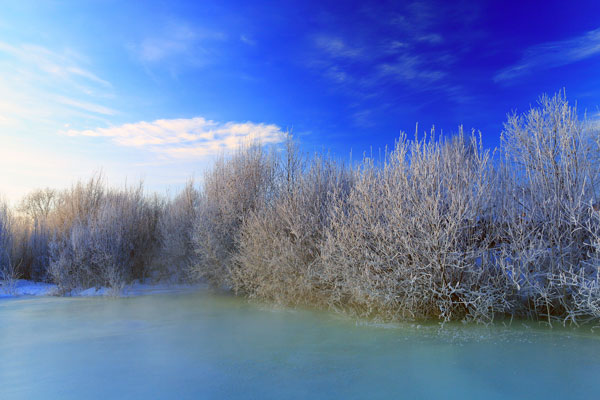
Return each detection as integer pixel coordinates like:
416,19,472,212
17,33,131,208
49,180,160,292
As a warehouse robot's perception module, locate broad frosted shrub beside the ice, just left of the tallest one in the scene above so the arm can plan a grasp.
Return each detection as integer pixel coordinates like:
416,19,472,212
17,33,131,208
323,131,505,320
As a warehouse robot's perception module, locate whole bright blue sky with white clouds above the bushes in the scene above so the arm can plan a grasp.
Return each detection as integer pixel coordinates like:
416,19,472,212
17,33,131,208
0,0,600,199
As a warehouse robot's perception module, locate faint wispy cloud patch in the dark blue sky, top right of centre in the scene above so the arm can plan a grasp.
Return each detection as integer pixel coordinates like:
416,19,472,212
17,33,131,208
302,0,480,126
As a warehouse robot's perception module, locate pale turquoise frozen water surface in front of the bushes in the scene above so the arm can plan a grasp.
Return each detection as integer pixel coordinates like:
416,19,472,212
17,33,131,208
0,291,600,400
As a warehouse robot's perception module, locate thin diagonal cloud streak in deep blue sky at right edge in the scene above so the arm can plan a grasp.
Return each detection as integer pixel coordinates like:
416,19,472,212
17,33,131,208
494,28,600,82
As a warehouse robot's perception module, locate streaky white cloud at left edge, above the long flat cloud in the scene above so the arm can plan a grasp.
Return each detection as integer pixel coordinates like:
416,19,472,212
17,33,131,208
0,41,116,125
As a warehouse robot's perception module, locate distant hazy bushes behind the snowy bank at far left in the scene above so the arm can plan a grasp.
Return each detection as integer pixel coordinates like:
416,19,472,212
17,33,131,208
2,176,163,293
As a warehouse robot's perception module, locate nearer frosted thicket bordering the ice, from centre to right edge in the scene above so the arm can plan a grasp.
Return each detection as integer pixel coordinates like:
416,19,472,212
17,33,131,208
211,95,600,322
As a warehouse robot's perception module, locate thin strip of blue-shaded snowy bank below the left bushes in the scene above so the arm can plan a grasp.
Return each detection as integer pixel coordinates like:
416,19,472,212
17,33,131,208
0,279,202,298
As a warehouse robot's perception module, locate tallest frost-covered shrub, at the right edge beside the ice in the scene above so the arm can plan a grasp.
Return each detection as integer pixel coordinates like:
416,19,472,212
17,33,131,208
497,93,600,321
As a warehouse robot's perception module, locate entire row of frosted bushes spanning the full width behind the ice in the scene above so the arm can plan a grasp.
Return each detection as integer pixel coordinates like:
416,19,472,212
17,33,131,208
0,94,600,322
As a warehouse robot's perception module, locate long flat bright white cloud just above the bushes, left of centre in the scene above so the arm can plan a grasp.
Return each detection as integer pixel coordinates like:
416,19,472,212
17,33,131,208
62,117,285,159
